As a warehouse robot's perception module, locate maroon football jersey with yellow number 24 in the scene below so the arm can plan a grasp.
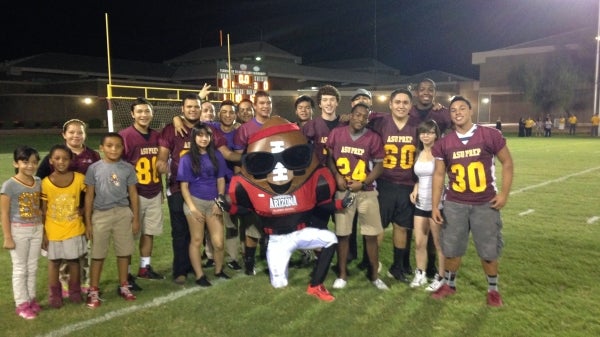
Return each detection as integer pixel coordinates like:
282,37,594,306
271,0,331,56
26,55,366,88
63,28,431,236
326,126,385,190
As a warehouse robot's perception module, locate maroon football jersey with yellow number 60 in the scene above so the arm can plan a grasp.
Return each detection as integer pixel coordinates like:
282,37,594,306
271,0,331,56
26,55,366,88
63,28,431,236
371,114,417,186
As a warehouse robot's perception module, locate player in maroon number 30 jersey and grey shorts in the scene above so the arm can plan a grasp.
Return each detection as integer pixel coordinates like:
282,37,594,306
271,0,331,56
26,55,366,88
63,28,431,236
431,96,513,307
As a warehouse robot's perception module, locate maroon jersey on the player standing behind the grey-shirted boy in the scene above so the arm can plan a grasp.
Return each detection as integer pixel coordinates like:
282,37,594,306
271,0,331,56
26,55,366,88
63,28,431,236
119,126,162,198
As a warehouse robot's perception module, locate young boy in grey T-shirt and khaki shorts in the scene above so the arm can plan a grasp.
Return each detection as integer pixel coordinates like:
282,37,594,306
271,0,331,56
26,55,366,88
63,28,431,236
85,132,140,309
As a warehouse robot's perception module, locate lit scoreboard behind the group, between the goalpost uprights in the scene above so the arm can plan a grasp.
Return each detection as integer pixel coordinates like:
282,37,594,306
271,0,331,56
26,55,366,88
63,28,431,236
217,63,270,102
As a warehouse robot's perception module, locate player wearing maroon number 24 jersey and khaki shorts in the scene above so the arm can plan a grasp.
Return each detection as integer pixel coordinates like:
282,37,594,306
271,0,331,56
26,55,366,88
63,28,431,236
326,103,388,290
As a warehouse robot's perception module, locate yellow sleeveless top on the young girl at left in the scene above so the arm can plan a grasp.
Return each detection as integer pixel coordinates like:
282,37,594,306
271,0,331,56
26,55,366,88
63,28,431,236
42,172,85,241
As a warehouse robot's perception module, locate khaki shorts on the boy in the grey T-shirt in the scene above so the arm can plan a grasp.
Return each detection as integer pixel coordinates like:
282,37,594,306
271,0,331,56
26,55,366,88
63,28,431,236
92,207,134,259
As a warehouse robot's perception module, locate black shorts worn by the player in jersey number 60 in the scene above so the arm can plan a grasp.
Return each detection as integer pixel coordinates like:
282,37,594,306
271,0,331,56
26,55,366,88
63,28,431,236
377,179,415,229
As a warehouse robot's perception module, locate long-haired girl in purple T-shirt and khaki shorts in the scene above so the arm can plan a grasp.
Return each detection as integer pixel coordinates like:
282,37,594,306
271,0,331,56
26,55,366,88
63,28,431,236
177,123,229,287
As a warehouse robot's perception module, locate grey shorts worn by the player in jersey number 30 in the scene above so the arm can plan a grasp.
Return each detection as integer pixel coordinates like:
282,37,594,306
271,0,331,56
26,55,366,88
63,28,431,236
440,201,504,261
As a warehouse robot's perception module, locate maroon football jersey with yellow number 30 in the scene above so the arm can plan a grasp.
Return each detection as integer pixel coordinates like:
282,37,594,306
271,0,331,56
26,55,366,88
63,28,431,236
431,125,506,204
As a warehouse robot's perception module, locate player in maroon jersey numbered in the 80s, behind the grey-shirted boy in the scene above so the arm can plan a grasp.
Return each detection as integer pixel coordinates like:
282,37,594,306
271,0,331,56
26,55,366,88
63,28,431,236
119,98,164,284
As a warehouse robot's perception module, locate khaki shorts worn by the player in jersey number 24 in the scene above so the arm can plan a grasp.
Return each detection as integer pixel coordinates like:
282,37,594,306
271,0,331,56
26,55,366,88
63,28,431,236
335,191,383,236
